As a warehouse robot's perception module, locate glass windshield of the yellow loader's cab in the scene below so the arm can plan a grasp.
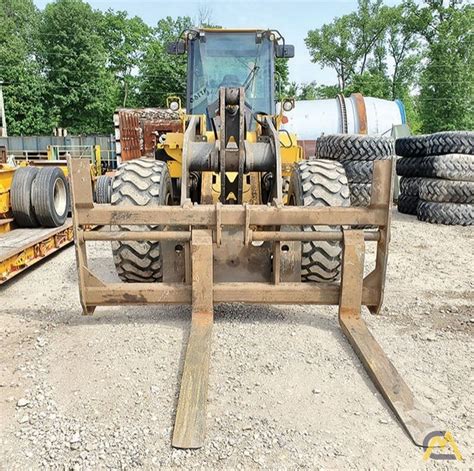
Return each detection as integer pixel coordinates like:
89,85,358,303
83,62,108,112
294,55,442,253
187,32,275,119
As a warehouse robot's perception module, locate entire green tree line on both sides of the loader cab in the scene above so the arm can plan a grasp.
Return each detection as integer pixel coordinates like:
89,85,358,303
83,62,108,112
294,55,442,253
0,0,474,135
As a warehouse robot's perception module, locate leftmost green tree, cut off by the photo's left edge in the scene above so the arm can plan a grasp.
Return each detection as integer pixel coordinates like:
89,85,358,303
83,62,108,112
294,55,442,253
0,0,52,135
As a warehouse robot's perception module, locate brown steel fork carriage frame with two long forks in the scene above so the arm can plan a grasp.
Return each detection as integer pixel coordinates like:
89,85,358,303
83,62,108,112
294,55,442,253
69,158,433,448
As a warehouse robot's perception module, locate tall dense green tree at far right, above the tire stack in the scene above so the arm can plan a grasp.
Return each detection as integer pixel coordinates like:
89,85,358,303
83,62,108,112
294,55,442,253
420,1,474,133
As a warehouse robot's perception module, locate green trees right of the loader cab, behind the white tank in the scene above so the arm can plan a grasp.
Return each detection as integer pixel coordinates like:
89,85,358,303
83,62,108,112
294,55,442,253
302,0,474,133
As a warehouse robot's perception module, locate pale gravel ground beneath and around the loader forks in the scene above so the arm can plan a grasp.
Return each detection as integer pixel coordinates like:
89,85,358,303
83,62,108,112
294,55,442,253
0,212,474,470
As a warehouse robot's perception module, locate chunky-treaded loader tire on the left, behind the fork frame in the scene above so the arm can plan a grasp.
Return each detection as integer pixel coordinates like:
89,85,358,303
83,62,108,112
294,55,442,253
111,158,172,283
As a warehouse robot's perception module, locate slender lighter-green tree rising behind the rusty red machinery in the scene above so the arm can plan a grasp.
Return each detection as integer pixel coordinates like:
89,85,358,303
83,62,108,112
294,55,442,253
100,10,151,107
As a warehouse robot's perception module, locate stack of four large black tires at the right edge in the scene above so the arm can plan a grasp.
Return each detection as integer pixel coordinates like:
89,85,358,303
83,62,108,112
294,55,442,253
395,131,474,226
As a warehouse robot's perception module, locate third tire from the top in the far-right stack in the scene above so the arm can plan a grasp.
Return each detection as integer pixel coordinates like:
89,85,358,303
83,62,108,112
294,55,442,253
420,178,474,204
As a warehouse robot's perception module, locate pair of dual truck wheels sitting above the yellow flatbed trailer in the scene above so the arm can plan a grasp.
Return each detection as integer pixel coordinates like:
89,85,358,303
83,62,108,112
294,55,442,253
10,167,70,227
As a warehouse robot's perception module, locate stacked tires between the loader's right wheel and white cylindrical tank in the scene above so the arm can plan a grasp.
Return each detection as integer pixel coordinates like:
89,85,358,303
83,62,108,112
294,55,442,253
317,134,395,206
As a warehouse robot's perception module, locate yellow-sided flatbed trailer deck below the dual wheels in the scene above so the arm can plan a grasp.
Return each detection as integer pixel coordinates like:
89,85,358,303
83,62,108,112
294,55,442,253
0,218,73,285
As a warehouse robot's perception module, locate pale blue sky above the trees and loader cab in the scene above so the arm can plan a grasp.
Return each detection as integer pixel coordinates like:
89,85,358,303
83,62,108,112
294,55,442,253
35,0,398,84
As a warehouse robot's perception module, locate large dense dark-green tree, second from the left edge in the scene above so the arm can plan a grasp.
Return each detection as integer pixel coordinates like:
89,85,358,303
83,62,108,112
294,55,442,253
40,0,118,133
